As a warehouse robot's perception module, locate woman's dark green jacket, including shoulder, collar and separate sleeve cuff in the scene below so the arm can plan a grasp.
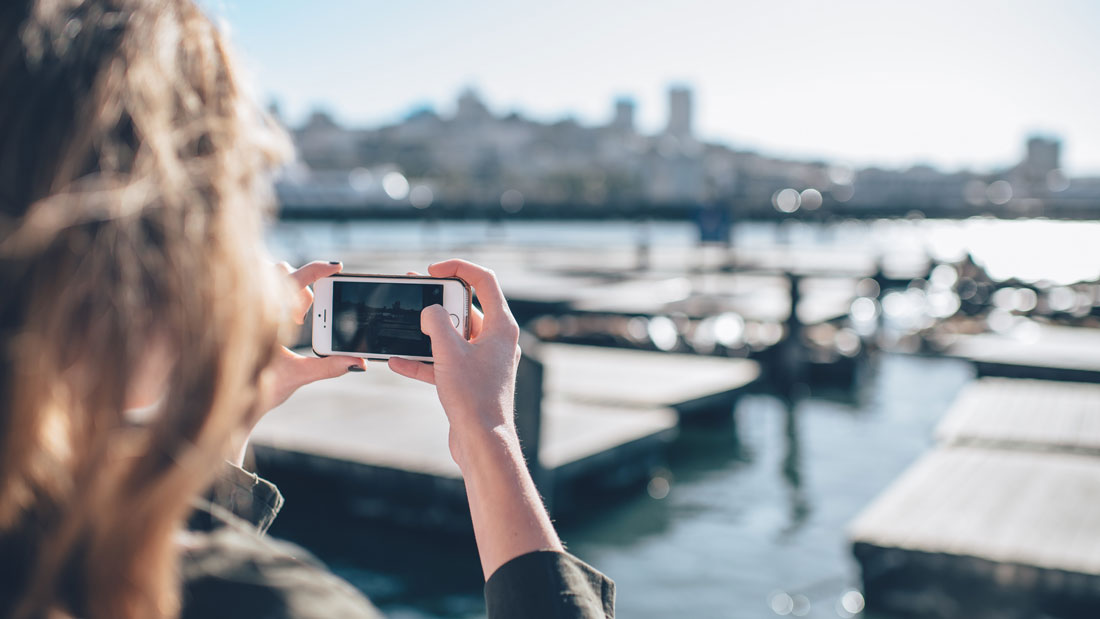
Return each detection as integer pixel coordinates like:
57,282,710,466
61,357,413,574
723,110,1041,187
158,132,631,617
180,466,615,619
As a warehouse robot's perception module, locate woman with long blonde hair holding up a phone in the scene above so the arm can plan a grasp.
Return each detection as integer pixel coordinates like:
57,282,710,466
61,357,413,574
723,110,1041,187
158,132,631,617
0,0,614,619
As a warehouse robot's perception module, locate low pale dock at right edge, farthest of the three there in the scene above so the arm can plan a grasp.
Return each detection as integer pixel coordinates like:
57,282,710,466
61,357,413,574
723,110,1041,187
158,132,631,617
945,323,1100,383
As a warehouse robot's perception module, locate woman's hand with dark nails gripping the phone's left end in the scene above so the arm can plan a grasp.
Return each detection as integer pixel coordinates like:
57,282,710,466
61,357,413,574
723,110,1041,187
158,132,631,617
256,262,366,421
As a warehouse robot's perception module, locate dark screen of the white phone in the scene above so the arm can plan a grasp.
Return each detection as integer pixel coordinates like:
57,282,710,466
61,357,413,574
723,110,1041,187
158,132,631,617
332,281,443,356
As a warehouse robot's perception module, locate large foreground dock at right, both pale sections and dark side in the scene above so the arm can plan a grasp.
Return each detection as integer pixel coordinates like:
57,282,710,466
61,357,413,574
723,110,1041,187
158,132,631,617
849,377,1100,619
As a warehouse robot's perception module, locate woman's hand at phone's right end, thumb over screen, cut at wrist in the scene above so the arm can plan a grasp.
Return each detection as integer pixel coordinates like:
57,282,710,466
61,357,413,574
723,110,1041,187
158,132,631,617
389,259,519,468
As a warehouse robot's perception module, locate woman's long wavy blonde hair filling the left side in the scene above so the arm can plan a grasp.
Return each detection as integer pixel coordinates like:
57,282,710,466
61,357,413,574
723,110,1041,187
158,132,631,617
0,0,286,619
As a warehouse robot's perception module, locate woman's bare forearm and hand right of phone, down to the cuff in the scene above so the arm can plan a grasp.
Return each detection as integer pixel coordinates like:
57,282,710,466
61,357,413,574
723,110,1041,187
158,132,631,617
389,259,562,578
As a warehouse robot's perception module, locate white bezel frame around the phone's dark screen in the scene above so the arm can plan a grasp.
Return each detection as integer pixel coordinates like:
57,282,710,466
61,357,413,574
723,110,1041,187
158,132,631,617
310,273,471,363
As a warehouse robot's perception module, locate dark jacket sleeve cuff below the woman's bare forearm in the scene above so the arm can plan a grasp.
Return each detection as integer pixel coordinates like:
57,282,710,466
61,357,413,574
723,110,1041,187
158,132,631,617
485,551,615,619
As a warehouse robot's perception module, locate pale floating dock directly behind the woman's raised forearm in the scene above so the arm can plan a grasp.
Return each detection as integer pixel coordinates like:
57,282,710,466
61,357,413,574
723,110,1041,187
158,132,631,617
252,364,677,528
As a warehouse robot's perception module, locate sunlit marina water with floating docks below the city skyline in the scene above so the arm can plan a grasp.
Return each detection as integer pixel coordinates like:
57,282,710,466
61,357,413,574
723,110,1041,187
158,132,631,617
255,222,1097,619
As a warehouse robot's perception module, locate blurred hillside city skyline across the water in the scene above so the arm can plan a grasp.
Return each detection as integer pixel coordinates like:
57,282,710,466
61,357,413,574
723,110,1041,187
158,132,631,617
275,86,1100,217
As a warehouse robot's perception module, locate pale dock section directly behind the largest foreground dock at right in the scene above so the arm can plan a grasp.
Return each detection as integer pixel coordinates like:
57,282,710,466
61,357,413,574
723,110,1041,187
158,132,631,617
936,377,1100,455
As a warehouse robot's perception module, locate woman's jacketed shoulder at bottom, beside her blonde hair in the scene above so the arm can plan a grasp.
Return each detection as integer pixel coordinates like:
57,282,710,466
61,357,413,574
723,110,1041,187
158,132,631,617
179,514,382,619
